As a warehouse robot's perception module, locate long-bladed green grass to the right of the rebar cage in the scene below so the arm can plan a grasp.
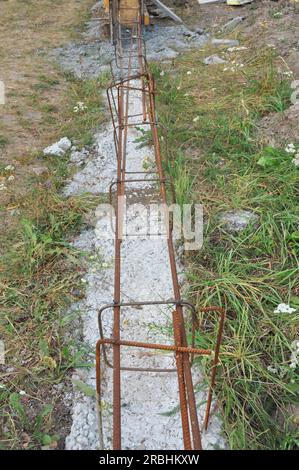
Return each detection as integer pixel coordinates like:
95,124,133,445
153,48,299,449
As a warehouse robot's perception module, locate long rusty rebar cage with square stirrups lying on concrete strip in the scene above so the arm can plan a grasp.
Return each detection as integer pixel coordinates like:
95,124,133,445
96,4,225,450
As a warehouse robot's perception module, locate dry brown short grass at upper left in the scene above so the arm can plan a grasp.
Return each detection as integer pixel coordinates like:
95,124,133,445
0,0,93,213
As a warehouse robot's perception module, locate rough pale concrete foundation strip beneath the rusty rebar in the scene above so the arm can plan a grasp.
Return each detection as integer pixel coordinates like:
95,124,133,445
66,4,225,450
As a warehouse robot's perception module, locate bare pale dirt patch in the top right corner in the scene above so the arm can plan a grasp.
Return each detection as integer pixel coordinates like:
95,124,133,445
180,0,299,66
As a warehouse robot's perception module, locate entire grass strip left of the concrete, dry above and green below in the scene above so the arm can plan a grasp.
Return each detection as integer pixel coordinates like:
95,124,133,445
0,0,107,449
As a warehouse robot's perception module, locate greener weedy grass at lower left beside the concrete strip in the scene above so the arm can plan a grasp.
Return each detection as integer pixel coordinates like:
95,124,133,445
0,183,86,449
